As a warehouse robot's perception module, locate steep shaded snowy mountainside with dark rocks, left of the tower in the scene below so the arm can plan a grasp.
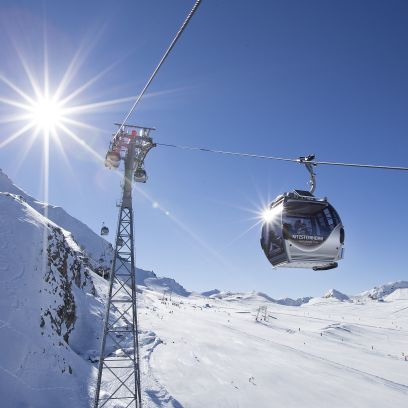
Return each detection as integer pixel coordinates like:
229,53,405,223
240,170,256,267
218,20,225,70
0,193,103,408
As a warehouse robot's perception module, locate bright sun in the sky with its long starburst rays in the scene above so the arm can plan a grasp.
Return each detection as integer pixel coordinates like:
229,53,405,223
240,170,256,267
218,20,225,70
0,45,143,163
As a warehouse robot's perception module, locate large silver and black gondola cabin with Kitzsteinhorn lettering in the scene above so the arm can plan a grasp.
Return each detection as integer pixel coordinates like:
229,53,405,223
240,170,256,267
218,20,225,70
261,190,344,270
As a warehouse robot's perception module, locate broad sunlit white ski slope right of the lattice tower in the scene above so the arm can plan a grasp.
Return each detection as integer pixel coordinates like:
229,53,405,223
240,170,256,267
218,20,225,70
140,291,408,408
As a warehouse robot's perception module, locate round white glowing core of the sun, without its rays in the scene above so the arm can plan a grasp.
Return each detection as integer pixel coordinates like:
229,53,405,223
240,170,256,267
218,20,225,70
30,97,64,132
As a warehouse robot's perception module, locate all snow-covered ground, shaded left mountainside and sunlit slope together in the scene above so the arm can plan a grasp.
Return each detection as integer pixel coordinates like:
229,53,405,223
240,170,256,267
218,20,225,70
0,168,408,408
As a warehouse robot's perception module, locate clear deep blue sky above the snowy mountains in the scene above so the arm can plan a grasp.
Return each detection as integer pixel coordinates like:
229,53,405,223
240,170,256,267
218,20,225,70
0,0,408,297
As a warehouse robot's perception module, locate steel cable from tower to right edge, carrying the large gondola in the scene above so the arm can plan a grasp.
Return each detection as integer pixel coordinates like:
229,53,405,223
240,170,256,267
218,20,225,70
156,143,408,171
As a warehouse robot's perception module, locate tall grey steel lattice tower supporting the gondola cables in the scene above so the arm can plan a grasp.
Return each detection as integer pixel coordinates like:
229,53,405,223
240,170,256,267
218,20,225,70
94,125,155,408
